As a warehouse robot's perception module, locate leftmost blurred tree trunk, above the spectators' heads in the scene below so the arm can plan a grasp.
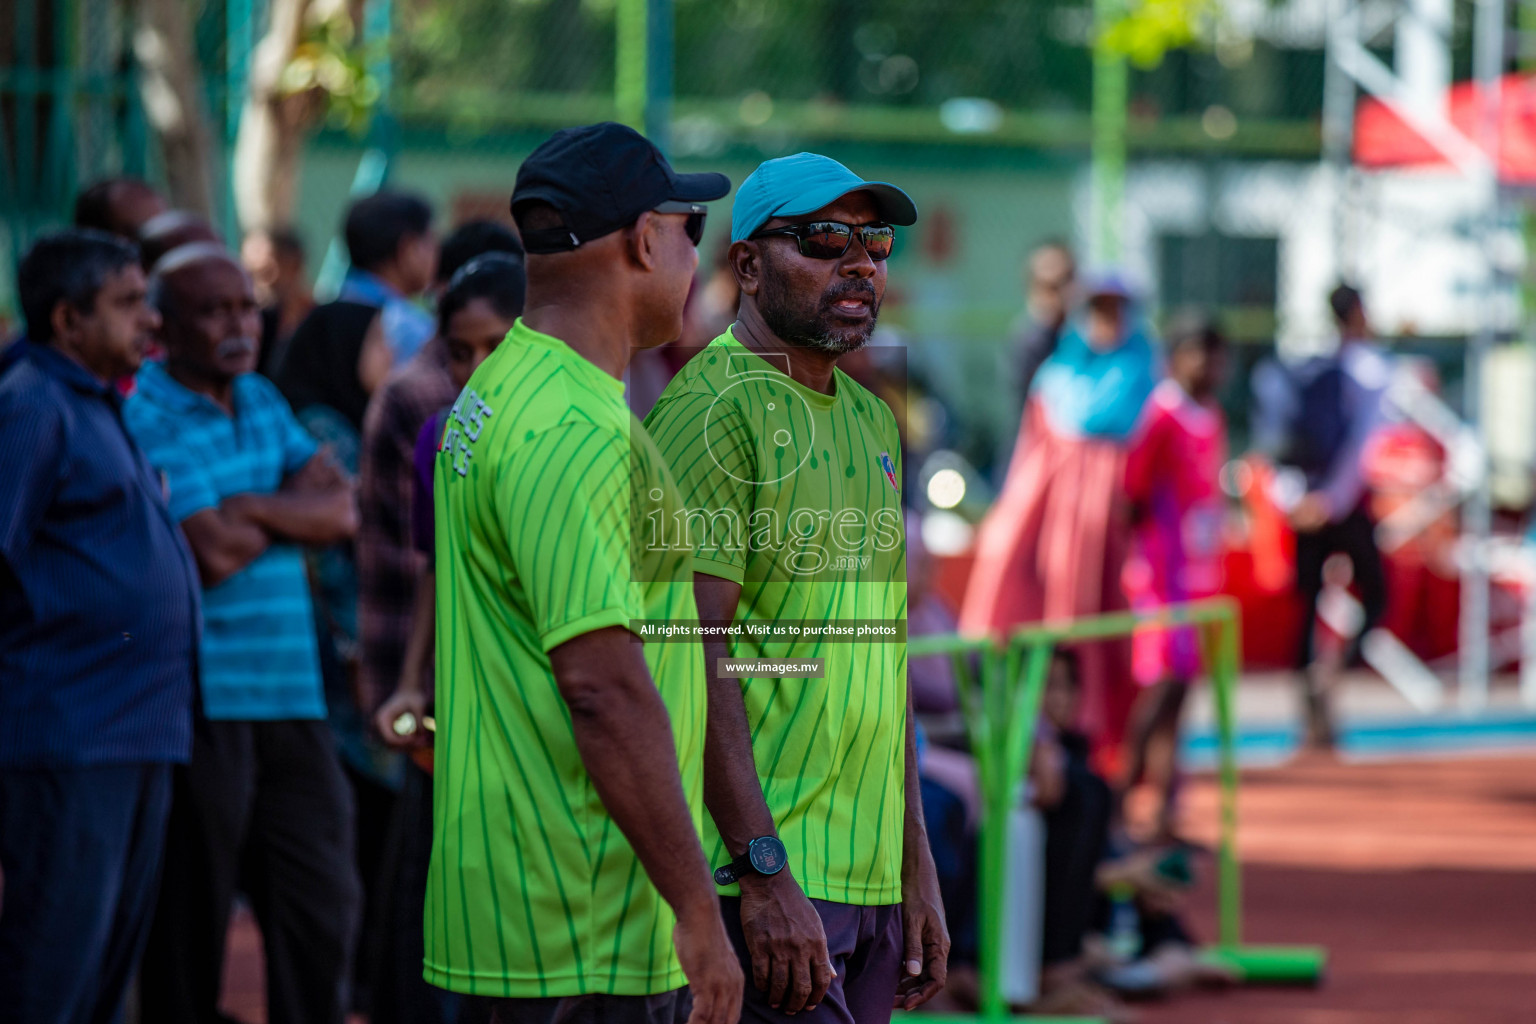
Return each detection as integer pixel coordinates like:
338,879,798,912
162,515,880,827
134,0,214,218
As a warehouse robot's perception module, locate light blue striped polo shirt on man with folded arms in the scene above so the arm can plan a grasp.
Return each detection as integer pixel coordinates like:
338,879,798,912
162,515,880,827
124,364,326,722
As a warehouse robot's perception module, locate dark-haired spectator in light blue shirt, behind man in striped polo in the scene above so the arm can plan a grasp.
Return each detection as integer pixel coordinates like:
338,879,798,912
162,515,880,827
336,192,438,362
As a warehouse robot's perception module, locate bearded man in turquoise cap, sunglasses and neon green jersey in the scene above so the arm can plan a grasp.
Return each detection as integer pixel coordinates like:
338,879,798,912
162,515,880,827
647,154,949,1024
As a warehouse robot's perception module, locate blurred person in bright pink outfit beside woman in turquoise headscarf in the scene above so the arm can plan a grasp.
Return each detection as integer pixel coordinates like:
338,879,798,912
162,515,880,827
1120,316,1227,840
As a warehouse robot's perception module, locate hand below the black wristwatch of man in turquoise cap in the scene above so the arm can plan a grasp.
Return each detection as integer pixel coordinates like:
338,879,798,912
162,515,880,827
740,869,833,1013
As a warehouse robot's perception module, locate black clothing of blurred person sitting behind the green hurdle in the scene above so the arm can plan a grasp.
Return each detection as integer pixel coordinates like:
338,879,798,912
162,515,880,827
1040,749,1111,966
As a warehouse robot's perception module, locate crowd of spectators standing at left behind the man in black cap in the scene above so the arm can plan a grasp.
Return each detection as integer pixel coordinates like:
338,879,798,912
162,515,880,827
0,180,524,1021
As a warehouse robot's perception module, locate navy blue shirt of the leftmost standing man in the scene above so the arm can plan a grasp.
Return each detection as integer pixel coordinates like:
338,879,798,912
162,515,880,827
0,341,198,768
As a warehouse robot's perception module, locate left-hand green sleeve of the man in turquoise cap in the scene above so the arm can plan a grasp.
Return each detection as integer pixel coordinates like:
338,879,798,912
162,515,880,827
645,391,757,583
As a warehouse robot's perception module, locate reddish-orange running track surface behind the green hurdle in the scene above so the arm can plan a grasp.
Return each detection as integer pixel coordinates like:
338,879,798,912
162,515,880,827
224,751,1536,1024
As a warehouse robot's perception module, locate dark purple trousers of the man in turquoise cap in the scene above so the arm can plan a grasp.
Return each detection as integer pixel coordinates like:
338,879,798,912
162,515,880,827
720,897,905,1024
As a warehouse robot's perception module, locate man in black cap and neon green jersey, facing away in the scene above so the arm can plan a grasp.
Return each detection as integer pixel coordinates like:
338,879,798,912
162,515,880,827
425,124,742,1024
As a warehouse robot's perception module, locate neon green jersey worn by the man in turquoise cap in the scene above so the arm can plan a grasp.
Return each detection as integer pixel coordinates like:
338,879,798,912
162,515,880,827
645,332,906,906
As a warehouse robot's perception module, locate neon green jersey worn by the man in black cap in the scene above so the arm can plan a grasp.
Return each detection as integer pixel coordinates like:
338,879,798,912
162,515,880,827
424,319,707,996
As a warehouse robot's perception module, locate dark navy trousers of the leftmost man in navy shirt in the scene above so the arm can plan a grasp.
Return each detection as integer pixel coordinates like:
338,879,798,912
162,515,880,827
0,765,170,1024
